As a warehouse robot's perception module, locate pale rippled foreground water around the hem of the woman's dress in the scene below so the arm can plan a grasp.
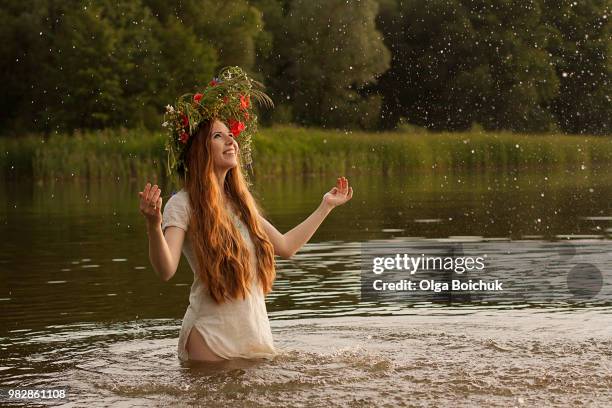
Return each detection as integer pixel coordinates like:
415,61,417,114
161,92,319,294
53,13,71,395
0,310,612,407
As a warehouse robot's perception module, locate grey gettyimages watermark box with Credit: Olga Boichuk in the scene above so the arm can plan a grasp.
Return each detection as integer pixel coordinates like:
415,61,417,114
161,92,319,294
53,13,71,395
361,240,612,304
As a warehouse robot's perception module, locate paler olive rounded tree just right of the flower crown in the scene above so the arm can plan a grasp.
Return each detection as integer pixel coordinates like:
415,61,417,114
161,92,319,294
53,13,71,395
285,0,390,127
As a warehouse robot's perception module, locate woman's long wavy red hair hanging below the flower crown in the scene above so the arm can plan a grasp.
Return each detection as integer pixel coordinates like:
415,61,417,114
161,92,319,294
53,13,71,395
179,120,276,303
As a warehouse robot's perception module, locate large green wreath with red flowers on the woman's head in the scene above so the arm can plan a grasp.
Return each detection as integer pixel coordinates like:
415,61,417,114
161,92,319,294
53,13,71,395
162,67,274,182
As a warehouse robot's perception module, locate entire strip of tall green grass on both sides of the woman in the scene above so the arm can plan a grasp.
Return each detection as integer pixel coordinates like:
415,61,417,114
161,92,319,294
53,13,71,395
0,126,612,180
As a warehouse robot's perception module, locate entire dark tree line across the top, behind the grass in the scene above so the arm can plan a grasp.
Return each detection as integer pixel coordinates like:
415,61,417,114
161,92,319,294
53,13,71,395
0,0,612,135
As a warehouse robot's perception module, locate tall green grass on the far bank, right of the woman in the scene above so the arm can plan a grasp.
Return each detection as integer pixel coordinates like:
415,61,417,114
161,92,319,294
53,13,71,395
253,127,612,174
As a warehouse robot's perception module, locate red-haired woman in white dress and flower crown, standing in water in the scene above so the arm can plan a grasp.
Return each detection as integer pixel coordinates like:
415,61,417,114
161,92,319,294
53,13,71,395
138,68,353,361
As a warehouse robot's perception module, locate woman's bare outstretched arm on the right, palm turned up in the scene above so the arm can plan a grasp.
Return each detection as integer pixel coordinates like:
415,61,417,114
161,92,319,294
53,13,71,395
259,177,353,259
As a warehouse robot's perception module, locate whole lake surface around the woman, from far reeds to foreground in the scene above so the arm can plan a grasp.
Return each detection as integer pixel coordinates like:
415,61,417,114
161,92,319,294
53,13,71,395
0,171,612,406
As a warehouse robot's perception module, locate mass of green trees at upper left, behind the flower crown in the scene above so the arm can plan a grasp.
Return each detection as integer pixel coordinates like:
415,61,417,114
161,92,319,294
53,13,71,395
0,0,261,134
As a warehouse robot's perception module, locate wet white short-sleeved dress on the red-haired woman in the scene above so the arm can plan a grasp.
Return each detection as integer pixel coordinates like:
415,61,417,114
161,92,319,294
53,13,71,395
162,189,276,361
